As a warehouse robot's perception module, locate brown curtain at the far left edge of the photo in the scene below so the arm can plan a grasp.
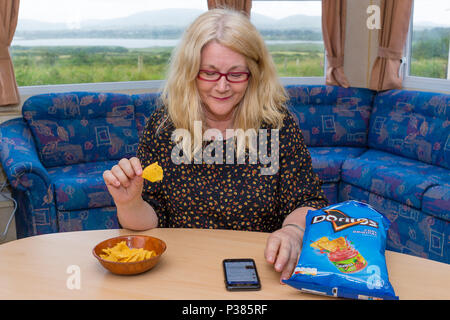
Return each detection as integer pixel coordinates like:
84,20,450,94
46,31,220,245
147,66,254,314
0,0,20,106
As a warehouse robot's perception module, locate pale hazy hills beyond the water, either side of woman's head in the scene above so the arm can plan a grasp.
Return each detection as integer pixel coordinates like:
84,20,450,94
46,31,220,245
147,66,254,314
16,9,321,32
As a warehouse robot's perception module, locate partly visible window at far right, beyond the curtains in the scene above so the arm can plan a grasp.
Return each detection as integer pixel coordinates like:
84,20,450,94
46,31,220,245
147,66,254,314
404,0,450,91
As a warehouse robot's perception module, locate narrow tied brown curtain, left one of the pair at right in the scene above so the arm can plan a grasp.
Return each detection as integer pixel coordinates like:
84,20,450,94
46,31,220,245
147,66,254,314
322,0,350,88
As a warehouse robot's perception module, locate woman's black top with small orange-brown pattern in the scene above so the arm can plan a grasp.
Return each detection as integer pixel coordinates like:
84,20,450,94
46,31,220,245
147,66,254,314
137,109,327,232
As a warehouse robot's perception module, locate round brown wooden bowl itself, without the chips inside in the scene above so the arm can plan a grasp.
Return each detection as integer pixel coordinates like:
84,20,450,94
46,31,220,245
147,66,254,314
92,235,166,275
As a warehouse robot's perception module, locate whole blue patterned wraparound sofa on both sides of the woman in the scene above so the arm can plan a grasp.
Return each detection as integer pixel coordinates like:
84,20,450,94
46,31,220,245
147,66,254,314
0,86,450,263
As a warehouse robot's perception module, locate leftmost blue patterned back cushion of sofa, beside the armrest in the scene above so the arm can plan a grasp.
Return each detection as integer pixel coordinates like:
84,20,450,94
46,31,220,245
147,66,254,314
22,92,138,167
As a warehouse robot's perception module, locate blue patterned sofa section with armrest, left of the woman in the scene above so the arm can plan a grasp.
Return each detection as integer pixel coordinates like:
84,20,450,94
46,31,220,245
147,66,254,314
0,92,156,238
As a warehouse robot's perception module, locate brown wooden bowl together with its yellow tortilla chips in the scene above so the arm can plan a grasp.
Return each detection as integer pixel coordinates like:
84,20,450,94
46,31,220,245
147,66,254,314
92,235,166,275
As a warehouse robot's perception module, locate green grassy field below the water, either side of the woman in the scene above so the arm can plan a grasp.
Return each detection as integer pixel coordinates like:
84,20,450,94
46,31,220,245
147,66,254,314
11,44,324,86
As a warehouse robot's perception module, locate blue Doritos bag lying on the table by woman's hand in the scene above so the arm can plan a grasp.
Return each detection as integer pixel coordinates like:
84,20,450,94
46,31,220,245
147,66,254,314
283,200,398,300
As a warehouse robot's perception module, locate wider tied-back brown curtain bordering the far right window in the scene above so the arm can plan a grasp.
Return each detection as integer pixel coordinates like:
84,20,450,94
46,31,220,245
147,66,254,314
369,0,414,91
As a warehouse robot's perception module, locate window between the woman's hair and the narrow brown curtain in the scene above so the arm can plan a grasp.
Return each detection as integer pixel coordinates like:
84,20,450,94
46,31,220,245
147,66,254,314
252,0,325,77
